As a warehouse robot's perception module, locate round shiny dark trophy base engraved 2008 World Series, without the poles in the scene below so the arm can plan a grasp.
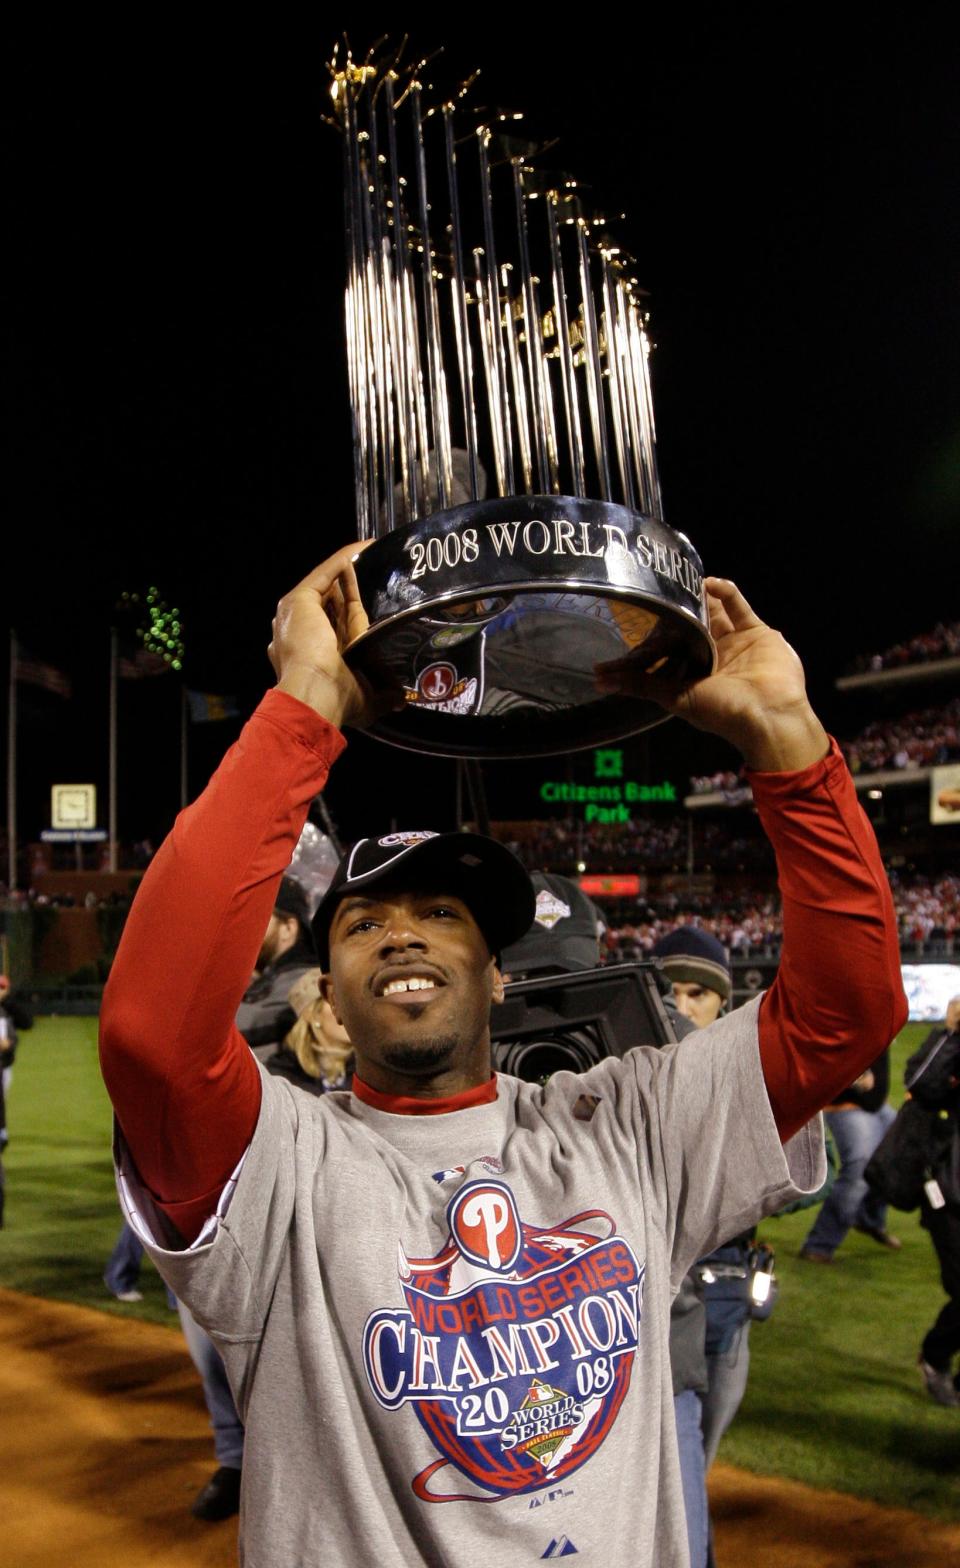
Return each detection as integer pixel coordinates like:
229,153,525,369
347,495,715,757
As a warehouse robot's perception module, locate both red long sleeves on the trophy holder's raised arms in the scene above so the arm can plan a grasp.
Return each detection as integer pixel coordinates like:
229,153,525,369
100,691,907,1240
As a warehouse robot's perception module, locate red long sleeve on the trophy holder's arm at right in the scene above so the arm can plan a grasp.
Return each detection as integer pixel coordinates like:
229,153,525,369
750,742,907,1142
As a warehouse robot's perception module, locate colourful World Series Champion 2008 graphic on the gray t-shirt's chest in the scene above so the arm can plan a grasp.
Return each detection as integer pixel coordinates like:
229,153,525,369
364,1181,643,1502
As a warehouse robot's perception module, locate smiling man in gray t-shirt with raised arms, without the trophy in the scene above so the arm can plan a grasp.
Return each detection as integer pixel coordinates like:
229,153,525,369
102,547,905,1568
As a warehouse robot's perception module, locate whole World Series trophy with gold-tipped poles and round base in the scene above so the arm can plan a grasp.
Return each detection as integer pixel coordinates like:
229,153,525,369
329,49,715,757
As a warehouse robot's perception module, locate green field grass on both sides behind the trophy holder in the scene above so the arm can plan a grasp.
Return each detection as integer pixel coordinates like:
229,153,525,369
0,1018,960,1519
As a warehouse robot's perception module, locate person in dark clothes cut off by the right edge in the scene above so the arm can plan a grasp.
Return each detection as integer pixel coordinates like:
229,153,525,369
904,996,960,1406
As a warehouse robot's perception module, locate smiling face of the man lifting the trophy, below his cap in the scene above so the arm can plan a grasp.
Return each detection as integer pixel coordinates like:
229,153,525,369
323,887,504,1094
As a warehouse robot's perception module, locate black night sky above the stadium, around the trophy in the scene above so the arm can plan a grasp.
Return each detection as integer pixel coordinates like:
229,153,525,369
3,8,960,839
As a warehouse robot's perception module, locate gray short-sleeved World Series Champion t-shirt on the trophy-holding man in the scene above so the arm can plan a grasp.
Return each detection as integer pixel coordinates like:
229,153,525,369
118,1004,825,1568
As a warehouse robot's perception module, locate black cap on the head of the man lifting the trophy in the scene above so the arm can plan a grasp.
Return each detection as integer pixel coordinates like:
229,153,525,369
314,829,536,969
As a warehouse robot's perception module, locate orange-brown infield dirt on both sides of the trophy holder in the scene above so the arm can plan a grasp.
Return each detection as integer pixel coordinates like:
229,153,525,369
0,1290,960,1568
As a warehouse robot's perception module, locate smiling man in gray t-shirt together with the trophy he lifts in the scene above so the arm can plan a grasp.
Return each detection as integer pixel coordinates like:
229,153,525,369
102,49,905,1568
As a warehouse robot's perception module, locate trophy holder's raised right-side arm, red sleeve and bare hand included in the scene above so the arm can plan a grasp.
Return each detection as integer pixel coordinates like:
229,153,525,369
598,577,907,1140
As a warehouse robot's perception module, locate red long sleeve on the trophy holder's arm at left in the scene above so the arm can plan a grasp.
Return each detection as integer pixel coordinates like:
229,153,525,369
100,691,345,1240
